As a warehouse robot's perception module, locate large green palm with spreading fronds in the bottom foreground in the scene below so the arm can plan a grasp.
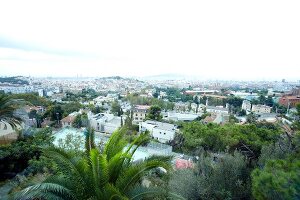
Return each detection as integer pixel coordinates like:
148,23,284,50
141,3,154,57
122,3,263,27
14,131,180,200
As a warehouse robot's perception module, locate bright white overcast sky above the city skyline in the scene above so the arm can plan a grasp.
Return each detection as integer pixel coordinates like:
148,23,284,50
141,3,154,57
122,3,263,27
0,0,300,80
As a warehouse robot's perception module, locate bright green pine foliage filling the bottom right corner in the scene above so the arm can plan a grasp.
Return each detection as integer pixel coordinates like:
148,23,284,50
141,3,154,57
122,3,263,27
252,132,300,199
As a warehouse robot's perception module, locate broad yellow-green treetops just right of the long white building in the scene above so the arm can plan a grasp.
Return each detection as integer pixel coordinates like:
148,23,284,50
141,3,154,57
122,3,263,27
182,122,281,157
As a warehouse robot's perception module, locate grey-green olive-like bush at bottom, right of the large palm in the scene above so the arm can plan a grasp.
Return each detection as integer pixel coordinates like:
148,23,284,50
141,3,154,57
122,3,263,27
170,152,251,200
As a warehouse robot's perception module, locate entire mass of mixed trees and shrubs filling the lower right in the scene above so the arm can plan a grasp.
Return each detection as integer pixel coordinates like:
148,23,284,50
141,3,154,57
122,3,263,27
169,122,300,199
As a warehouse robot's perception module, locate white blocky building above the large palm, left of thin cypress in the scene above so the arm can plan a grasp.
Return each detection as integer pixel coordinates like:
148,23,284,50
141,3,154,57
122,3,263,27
88,113,126,134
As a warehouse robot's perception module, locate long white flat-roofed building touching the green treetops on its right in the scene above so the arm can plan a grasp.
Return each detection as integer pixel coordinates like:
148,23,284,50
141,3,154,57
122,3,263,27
139,120,177,143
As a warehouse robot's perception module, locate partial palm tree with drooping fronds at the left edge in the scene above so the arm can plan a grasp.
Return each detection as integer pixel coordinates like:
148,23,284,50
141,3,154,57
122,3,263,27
0,95,21,129
